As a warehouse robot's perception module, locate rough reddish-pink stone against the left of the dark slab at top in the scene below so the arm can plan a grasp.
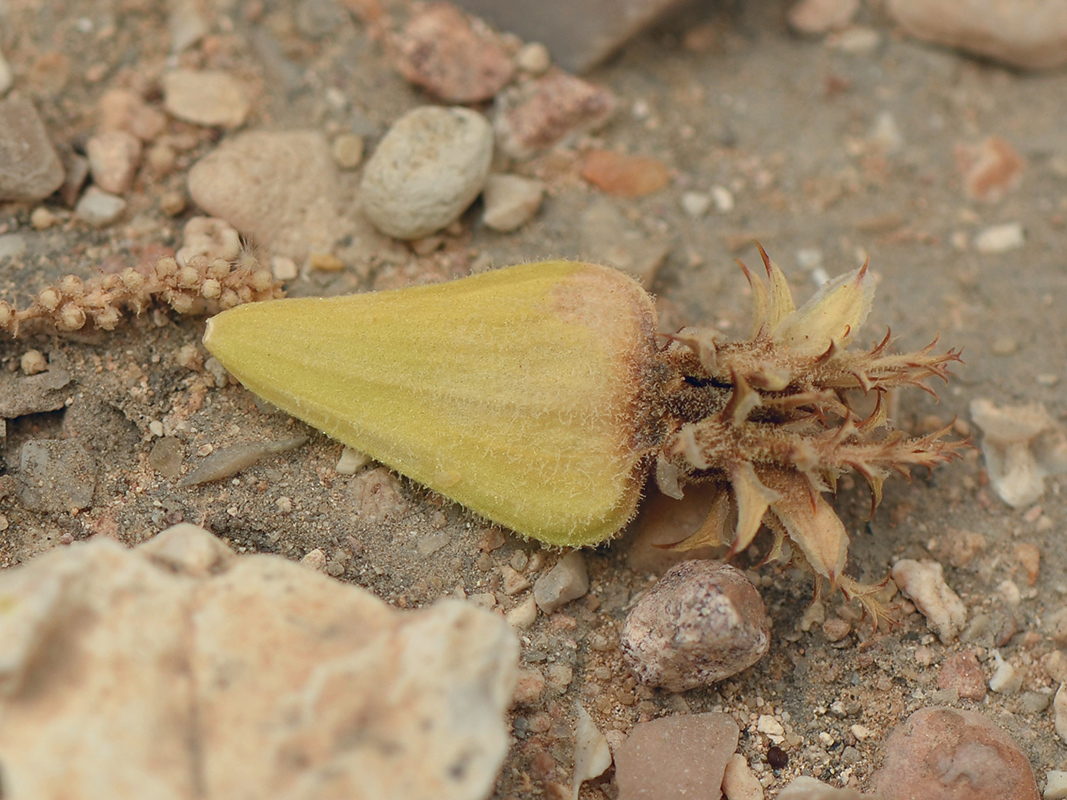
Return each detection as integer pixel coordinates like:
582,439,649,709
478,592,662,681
396,2,515,103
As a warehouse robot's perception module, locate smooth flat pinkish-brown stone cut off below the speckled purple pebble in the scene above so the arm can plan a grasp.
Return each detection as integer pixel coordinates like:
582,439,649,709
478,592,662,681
615,711,739,800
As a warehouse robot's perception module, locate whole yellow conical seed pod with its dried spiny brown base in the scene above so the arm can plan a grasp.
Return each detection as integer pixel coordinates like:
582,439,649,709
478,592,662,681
204,249,958,608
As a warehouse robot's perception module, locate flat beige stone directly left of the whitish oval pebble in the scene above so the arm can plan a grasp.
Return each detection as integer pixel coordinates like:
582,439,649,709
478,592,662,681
189,131,352,262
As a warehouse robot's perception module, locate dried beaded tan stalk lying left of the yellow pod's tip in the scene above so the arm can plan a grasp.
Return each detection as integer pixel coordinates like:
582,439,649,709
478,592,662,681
0,253,283,336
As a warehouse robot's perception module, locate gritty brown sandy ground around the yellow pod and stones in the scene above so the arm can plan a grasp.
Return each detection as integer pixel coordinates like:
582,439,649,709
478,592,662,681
0,0,1067,800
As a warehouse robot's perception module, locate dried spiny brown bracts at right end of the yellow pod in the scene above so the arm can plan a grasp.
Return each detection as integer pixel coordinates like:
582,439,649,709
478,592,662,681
655,247,962,613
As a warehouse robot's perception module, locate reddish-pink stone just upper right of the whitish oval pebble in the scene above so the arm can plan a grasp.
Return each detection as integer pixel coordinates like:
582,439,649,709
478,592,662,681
494,73,616,159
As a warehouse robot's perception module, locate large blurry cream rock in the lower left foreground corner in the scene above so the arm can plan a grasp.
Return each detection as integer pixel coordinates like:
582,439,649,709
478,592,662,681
0,525,517,800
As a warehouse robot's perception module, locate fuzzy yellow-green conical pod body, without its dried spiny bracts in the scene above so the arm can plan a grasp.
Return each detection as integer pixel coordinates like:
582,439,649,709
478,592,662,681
204,261,656,545
